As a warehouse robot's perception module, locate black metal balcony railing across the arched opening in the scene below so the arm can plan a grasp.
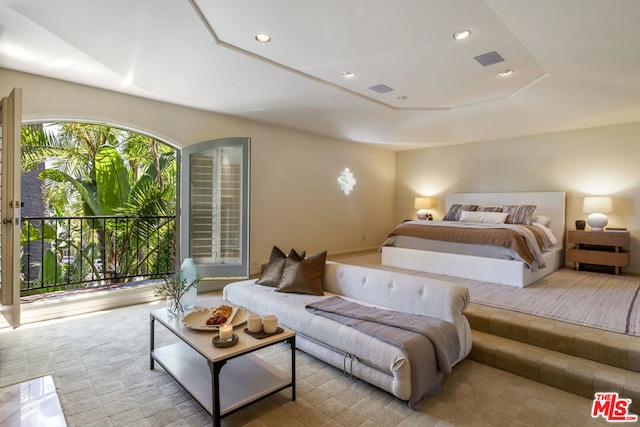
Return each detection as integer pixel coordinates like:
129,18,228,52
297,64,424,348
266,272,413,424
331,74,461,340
20,216,176,297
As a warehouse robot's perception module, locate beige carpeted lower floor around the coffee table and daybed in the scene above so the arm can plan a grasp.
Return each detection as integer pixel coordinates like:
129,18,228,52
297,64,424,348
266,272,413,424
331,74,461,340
0,296,607,427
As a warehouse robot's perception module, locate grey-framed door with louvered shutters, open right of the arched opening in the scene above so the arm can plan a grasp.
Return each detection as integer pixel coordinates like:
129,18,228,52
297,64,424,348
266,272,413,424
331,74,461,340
178,138,250,279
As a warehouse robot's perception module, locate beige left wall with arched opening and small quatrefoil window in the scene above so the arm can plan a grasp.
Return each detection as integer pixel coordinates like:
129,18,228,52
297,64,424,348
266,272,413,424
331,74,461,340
0,68,395,273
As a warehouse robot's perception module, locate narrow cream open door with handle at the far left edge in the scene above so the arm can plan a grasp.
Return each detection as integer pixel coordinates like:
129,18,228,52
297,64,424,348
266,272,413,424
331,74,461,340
0,88,22,328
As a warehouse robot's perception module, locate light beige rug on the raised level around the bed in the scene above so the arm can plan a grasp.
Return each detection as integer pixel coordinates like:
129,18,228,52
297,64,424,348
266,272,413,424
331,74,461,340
336,254,640,336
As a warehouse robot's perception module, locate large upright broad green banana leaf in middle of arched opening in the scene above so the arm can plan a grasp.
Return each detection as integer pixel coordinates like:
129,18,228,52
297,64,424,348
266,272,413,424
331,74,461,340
95,145,130,215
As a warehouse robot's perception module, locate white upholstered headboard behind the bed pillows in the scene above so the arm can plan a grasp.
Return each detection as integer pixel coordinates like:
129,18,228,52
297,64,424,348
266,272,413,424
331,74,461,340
447,191,566,247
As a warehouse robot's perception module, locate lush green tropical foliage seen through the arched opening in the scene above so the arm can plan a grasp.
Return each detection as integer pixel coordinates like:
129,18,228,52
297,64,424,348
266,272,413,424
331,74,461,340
22,123,176,292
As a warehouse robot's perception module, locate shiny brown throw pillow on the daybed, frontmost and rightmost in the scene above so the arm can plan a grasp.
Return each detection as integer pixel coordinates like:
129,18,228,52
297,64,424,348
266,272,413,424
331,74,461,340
276,251,327,295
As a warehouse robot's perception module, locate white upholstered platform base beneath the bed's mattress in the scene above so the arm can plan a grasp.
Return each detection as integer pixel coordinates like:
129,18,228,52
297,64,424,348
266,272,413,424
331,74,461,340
382,246,564,288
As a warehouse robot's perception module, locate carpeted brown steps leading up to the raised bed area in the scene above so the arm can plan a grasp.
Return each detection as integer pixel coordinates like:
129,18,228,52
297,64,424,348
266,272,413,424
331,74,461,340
465,304,640,414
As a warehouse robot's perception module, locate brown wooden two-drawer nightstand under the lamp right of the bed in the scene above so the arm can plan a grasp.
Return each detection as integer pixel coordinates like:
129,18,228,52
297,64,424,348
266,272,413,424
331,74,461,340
567,230,631,274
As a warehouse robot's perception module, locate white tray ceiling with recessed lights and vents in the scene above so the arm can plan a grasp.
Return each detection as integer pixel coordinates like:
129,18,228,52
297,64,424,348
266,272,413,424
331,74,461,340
0,0,640,149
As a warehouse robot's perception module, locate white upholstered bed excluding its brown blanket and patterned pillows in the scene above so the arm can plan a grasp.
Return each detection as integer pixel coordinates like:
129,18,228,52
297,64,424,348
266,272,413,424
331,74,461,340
381,192,566,287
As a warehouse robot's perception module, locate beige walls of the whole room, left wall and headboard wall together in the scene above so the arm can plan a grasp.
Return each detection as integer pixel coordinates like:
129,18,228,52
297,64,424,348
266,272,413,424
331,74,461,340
6,68,640,272
